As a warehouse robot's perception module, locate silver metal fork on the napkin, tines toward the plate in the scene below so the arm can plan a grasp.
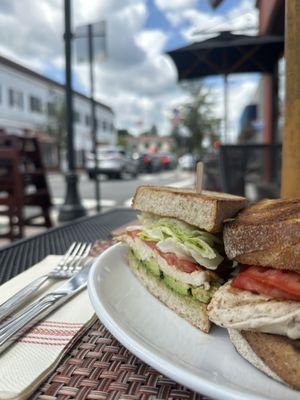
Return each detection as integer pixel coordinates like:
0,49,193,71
0,242,92,321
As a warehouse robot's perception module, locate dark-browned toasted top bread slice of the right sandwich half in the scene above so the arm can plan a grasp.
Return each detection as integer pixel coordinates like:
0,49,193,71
224,198,300,272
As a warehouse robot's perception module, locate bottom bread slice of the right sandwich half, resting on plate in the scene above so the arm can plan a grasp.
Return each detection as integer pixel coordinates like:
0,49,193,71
228,329,300,390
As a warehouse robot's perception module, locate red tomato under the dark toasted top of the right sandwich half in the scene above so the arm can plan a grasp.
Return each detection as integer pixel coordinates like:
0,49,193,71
231,266,300,301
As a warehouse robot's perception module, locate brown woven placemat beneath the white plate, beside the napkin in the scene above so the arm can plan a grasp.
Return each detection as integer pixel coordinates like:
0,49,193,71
32,321,209,400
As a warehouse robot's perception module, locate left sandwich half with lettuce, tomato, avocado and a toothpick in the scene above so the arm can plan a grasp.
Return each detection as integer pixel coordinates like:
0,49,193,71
119,186,246,332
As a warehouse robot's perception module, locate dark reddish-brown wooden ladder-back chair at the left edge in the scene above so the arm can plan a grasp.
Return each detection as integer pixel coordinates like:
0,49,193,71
0,136,52,240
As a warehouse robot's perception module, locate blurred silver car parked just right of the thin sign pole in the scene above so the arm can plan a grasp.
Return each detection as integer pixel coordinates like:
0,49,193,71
86,147,139,179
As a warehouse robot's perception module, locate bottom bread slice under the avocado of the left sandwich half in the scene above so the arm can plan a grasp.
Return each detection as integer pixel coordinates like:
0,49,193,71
128,252,210,333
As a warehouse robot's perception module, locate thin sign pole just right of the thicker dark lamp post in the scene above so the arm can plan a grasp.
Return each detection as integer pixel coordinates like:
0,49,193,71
88,24,101,212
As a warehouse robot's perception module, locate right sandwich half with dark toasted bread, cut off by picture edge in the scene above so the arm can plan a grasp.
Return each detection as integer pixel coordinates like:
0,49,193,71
208,198,300,389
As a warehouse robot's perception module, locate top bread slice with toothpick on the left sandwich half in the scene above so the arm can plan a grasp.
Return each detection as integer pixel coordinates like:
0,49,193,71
132,186,246,232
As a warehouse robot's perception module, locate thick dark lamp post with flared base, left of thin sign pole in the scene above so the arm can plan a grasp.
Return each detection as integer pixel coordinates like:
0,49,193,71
58,0,86,222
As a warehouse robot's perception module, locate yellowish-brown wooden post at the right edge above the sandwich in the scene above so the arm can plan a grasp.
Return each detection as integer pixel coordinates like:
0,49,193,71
281,0,300,198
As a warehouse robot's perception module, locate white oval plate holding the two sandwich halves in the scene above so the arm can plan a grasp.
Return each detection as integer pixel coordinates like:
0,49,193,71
88,244,300,400
